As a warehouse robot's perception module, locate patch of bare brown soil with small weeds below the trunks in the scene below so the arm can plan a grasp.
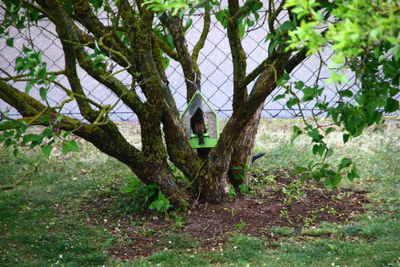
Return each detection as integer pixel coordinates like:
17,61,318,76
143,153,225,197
81,170,369,260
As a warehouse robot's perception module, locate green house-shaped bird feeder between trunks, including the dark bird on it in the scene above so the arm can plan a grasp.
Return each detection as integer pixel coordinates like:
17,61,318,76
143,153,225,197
181,90,219,148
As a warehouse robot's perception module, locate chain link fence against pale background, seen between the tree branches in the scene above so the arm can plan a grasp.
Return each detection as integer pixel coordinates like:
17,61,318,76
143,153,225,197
0,8,400,121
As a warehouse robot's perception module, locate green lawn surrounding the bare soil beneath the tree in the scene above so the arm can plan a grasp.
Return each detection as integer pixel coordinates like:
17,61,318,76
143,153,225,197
0,120,400,266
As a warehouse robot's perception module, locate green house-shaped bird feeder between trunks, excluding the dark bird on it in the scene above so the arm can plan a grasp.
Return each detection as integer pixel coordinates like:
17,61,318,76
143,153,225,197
181,90,219,148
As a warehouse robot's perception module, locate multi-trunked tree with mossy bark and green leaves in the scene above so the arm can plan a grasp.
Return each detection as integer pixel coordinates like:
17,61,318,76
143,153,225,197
0,0,400,203
